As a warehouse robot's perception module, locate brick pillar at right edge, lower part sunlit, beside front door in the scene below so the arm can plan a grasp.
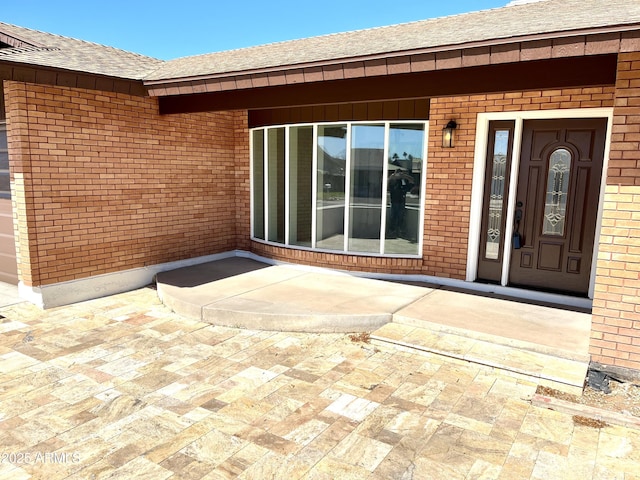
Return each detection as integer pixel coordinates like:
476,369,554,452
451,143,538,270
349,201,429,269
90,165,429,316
590,53,640,371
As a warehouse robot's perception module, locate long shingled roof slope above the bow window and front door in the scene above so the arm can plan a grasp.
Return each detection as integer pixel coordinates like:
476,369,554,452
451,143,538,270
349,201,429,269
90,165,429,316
145,0,640,83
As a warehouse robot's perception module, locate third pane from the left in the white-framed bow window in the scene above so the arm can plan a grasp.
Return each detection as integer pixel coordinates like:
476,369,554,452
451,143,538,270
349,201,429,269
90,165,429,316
289,127,313,247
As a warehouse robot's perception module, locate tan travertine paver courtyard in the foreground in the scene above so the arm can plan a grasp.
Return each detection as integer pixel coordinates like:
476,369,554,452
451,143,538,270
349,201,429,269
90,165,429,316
0,289,640,480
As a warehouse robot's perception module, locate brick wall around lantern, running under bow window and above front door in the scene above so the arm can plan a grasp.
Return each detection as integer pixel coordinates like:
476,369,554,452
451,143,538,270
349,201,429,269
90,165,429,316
251,87,614,279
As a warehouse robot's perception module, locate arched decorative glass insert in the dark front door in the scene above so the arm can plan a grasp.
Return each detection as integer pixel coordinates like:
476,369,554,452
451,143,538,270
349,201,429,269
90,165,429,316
542,148,571,236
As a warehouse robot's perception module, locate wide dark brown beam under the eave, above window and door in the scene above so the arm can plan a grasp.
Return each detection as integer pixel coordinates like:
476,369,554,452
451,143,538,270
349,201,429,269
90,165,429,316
158,54,617,114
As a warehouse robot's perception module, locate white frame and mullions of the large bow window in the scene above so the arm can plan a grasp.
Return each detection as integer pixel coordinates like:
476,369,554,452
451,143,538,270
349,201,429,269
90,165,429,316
249,119,429,259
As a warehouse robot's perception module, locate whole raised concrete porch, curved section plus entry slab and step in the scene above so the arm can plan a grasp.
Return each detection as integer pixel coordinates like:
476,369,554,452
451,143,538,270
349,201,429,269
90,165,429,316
157,257,591,393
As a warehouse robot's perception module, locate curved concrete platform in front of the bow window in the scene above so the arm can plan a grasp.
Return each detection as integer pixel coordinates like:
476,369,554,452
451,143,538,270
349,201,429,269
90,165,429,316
157,258,431,332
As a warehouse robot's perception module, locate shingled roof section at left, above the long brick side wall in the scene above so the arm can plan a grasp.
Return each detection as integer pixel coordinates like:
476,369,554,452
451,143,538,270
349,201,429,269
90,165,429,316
0,22,163,80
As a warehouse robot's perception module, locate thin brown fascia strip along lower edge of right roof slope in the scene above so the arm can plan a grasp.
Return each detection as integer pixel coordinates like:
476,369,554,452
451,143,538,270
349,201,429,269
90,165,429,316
144,24,640,88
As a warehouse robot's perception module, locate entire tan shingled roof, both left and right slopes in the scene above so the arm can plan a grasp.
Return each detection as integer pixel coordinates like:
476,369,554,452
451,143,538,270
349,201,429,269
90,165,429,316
0,0,640,87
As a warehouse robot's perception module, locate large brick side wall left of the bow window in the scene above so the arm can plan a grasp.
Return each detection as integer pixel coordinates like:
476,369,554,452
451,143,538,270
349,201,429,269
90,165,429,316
5,82,249,286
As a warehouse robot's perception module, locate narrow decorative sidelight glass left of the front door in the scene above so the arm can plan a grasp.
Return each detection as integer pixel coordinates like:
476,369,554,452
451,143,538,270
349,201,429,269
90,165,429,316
485,130,509,260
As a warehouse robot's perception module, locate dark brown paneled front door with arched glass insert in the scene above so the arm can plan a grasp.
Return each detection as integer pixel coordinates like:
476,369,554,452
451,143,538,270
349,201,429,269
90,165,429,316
509,119,607,295
